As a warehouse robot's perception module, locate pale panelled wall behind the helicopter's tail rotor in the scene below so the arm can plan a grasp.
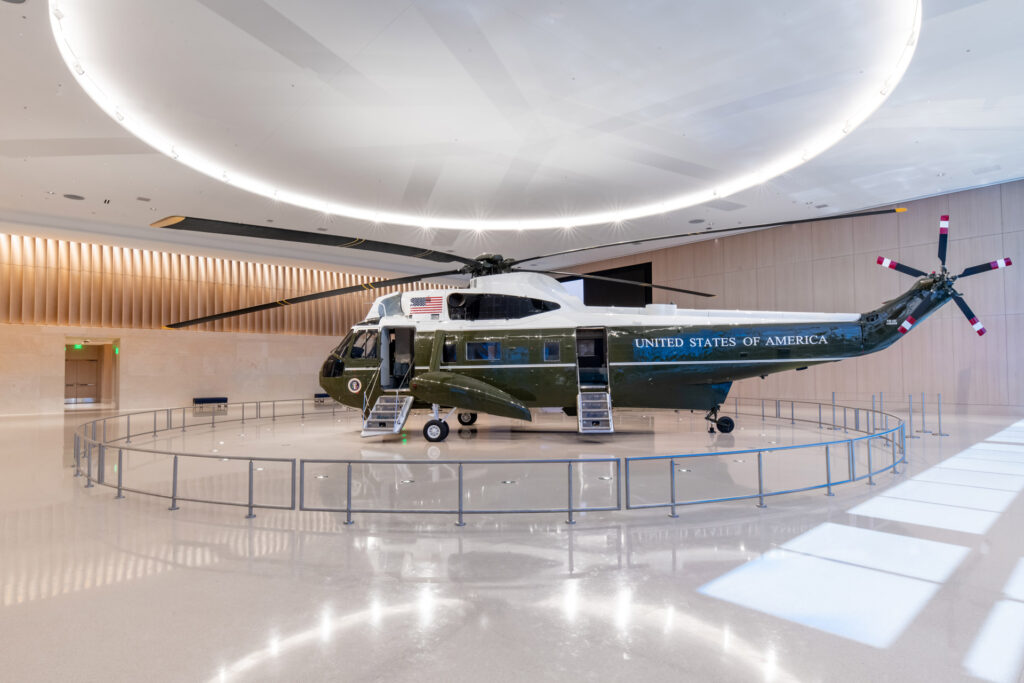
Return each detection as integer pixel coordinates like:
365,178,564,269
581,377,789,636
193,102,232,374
574,181,1024,412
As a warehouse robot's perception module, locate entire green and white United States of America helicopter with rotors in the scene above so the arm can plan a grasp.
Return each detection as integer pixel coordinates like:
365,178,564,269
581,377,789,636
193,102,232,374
153,208,1012,441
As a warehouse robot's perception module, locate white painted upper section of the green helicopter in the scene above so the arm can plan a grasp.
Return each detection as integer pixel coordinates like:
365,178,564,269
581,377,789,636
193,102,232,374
367,272,860,329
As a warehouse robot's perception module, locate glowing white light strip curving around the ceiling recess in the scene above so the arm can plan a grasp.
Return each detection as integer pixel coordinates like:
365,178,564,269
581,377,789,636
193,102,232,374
49,0,922,230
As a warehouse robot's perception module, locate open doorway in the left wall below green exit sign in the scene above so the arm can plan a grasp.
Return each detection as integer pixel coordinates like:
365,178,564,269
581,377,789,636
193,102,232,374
65,339,121,410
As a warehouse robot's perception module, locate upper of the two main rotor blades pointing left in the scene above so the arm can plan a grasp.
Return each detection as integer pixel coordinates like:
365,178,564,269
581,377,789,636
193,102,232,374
152,216,476,265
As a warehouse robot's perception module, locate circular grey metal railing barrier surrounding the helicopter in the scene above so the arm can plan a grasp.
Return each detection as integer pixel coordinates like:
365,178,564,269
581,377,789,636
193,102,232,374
74,398,906,526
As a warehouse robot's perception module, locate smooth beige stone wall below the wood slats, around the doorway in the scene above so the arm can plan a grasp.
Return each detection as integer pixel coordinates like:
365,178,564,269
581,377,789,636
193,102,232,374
0,325,331,415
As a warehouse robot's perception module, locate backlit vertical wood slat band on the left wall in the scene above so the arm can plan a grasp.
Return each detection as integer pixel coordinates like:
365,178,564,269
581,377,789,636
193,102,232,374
0,233,430,336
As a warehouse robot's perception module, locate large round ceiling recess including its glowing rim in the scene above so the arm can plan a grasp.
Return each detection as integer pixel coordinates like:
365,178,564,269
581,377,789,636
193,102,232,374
49,0,922,230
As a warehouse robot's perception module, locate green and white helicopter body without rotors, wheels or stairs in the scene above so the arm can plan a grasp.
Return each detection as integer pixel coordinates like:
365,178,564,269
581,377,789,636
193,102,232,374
319,273,948,420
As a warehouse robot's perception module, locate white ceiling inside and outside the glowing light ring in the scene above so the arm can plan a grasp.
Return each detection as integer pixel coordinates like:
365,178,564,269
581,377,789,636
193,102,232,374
0,0,1024,272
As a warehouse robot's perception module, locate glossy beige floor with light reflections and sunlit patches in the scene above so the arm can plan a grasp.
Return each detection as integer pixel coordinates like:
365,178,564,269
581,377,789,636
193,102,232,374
0,403,1024,681
